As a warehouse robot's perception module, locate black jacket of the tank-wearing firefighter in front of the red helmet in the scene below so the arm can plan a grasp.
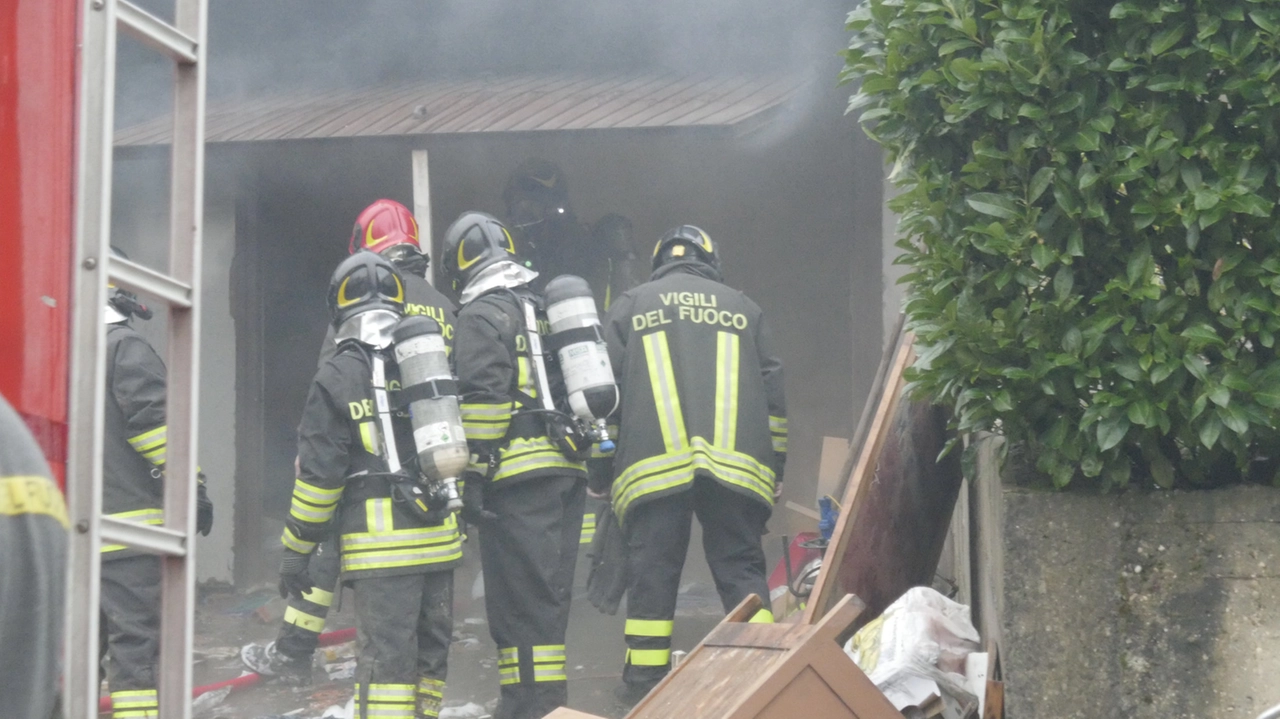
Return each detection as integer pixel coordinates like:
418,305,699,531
282,342,462,580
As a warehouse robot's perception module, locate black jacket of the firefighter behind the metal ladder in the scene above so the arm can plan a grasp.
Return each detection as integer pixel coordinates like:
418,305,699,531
102,322,169,559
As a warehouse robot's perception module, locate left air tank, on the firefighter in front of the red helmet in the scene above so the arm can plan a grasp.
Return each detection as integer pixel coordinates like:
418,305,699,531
392,315,470,512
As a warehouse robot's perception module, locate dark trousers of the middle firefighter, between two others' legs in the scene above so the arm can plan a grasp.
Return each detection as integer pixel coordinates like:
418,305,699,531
480,477,586,719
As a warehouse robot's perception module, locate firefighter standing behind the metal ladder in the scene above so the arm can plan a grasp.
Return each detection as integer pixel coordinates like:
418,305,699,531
99,269,214,718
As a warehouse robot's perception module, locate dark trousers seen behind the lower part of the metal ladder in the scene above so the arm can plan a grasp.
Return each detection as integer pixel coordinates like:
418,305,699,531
99,555,160,719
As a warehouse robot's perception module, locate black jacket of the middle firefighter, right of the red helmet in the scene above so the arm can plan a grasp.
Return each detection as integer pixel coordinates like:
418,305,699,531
453,287,586,486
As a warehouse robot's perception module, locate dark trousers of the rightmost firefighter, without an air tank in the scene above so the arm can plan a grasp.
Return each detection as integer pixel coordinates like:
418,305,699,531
622,476,773,686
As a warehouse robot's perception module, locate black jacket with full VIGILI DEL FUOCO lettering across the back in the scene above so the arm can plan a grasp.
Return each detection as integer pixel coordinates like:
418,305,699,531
604,262,787,523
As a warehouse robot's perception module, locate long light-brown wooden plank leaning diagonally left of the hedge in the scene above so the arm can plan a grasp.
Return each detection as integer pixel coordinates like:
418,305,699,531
801,333,915,624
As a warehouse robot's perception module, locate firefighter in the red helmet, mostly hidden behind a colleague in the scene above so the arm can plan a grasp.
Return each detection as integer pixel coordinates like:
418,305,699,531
241,200,454,684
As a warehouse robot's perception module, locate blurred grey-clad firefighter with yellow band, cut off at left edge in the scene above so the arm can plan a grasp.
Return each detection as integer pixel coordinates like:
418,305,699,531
0,397,67,719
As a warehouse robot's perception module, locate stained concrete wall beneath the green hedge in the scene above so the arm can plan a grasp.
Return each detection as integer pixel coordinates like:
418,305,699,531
975,437,1280,719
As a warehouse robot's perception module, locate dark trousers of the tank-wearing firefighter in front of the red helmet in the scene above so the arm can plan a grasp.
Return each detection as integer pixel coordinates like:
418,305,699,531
352,569,453,719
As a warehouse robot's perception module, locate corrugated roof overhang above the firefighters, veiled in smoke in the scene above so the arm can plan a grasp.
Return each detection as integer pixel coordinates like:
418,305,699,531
115,74,804,146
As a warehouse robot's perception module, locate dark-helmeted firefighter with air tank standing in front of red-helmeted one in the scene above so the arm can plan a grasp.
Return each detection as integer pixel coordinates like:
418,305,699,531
280,252,462,719
